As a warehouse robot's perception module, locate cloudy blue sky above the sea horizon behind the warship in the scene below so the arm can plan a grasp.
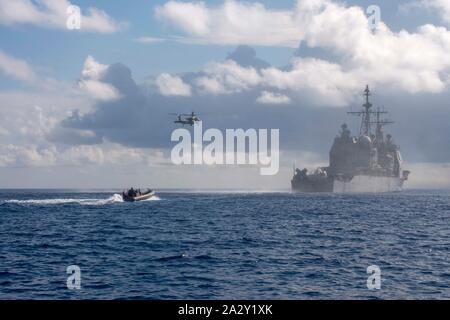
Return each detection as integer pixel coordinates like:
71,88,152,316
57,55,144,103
0,0,450,190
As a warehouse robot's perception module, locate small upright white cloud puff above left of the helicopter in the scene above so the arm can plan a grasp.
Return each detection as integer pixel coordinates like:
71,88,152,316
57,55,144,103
78,56,120,101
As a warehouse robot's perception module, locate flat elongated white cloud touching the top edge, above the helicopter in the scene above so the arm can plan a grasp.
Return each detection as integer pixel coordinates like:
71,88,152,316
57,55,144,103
155,0,302,47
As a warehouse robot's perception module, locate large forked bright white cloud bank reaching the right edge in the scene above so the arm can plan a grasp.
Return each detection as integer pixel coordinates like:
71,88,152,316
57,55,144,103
157,0,450,106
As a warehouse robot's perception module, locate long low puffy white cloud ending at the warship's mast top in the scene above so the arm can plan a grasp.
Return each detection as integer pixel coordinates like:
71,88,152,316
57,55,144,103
185,58,356,106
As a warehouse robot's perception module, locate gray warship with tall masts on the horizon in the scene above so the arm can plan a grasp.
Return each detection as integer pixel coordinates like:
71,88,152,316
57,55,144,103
291,86,410,193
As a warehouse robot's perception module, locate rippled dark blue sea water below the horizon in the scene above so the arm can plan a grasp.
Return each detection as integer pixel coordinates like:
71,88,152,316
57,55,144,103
0,190,450,299
